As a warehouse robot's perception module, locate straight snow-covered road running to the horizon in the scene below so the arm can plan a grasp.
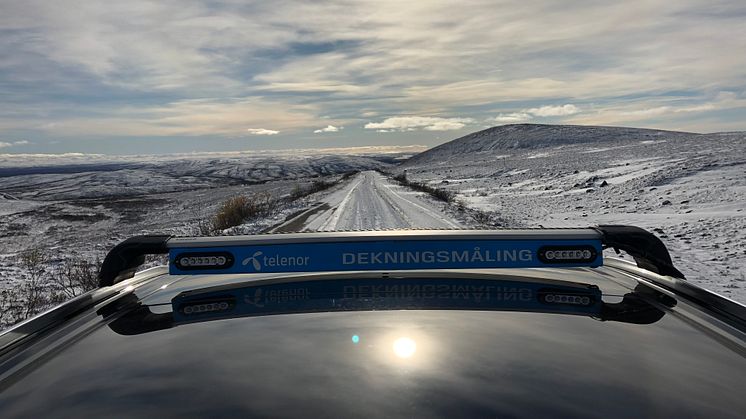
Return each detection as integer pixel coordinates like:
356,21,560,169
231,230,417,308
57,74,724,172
274,171,462,232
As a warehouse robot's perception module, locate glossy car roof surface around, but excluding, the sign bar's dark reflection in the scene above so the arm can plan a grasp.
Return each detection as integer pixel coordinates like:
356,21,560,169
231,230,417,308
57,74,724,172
0,261,746,417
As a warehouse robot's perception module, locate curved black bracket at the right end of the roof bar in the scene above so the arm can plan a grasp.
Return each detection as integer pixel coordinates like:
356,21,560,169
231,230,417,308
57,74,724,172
595,225,686,279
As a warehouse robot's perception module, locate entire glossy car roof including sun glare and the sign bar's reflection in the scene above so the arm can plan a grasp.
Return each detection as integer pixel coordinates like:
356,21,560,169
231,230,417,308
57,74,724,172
0,228,746,417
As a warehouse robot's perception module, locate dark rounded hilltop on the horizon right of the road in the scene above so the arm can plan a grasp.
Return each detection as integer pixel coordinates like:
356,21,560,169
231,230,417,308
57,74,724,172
403,124,705,166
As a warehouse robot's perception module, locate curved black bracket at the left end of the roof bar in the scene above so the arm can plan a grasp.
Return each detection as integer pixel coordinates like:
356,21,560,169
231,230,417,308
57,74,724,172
98,236,171,287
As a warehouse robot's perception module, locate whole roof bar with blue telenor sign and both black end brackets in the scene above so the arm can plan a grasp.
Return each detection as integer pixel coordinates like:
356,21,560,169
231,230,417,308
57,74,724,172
99,225,684,287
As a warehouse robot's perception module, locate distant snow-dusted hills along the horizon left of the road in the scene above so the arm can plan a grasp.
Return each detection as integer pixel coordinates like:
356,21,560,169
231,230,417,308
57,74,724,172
0,155,393,202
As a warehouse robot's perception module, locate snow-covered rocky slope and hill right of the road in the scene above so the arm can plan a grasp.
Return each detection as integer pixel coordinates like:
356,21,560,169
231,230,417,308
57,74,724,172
396,124,746,302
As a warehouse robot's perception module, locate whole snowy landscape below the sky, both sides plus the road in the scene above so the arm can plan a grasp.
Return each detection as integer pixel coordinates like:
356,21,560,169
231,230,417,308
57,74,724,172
0,125,746,328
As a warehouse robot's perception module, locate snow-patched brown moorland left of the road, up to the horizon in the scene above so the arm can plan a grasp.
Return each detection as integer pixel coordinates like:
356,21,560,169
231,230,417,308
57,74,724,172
0,148,408,316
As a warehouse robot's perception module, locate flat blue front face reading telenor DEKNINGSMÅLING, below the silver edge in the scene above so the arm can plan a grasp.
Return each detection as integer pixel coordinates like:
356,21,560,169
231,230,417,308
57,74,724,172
170,240,603,275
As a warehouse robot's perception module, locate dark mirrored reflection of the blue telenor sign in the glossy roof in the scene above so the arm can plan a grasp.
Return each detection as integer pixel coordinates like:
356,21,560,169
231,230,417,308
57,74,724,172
172,278,602,323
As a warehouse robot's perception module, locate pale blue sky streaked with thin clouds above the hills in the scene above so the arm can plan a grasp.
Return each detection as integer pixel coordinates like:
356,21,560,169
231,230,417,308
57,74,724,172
0,0,746,154
